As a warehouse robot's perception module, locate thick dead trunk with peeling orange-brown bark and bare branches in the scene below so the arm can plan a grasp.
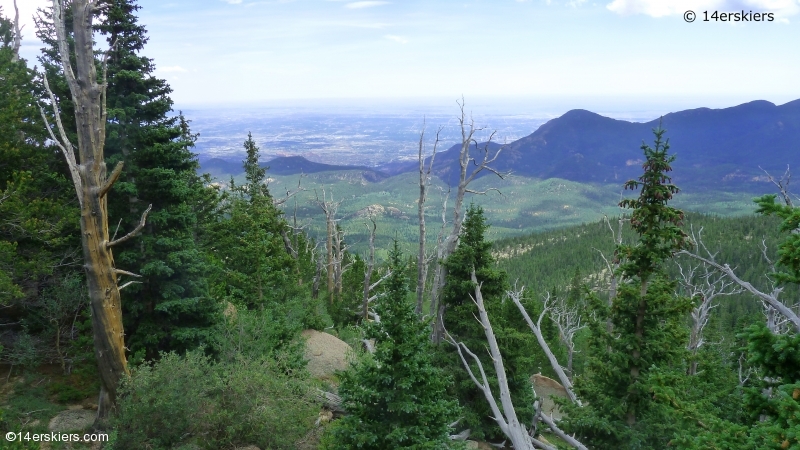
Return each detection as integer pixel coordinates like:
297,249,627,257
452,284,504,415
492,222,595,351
41,0,150,421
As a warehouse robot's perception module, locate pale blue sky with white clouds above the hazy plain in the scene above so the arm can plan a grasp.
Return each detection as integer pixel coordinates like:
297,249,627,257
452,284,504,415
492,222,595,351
0,0,800,113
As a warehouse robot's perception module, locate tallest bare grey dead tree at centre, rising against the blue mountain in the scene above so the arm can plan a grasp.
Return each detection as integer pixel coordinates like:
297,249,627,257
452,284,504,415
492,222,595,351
430,98,508,344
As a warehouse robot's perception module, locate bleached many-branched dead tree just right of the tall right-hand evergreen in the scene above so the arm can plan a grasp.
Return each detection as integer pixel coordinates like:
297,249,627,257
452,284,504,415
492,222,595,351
678,228,744,375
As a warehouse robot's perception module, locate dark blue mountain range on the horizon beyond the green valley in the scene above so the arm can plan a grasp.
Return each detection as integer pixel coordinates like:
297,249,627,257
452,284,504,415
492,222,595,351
201,100,800,190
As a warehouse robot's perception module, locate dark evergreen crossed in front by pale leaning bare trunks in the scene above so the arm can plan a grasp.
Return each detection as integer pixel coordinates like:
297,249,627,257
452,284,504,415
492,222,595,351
440,204,541,439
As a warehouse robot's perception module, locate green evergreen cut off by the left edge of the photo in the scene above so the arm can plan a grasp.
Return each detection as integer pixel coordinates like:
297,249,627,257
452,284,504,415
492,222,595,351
0,9,79,344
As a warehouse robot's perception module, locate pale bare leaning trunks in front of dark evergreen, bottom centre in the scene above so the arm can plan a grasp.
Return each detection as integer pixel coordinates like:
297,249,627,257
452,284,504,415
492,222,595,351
444,271,586,450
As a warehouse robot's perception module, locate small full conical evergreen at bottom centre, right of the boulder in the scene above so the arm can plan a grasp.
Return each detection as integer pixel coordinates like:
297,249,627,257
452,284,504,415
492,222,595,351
325,241,459,450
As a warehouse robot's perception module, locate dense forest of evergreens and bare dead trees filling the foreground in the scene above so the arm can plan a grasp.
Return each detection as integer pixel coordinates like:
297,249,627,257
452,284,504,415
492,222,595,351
0,0,800,450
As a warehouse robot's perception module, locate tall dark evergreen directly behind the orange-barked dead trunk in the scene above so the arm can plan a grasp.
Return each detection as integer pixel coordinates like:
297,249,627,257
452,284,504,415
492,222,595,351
96,0,219,357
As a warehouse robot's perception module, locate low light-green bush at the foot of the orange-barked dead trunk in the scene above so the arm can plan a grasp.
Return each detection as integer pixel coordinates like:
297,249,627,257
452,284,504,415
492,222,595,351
112,352,318,450
